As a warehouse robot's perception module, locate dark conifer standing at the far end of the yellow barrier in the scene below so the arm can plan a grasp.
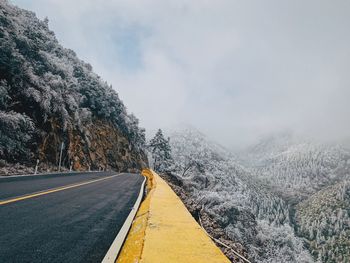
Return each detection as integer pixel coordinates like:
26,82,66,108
148,129,173,172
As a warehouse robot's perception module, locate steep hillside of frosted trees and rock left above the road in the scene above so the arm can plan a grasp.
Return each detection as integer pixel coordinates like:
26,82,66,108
0,0,147,171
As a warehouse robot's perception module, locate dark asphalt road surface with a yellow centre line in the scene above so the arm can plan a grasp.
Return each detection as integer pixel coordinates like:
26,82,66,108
0,173,143,263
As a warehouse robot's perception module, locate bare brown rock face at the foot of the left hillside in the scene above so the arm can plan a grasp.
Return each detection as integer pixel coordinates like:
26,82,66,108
39,120,147,171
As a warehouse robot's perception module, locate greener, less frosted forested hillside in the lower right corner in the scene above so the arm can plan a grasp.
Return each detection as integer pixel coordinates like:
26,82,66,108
296,180,350,263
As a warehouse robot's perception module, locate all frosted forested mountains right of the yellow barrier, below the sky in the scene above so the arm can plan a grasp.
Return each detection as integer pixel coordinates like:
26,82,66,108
169,126,350,262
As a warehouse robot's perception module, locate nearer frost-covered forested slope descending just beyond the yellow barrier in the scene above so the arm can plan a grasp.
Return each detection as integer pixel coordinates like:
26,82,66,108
170,129,313,262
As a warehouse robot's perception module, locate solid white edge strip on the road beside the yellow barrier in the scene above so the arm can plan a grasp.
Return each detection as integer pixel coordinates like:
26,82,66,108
102,177,146,263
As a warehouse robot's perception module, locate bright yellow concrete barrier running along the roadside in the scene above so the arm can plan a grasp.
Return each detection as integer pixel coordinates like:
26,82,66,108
117,170,230,263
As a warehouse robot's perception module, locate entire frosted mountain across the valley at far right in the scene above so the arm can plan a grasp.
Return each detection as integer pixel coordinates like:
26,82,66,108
245,134,350,263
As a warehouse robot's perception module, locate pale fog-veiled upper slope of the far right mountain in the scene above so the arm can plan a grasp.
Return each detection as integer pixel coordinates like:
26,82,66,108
246,135,350,199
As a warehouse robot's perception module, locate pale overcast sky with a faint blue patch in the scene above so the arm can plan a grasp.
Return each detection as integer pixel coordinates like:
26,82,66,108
12,0,350,147
